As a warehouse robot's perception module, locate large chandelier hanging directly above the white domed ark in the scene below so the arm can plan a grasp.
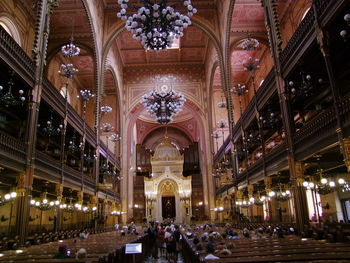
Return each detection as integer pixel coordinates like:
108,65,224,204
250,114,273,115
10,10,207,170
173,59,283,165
141,87,186,124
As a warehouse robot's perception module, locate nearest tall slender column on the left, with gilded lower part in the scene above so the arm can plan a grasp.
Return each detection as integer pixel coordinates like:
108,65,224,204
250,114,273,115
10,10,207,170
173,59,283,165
15,0,57,246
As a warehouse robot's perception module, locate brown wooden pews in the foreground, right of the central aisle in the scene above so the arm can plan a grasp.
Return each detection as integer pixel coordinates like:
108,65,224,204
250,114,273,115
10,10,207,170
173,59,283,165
183,227,350,263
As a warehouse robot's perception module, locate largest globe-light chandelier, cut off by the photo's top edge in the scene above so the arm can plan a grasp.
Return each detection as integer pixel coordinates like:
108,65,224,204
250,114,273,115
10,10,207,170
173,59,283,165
117,0,197,50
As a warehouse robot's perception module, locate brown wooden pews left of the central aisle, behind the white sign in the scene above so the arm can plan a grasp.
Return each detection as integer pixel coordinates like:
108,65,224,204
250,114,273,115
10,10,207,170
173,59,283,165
0,231,149,263
